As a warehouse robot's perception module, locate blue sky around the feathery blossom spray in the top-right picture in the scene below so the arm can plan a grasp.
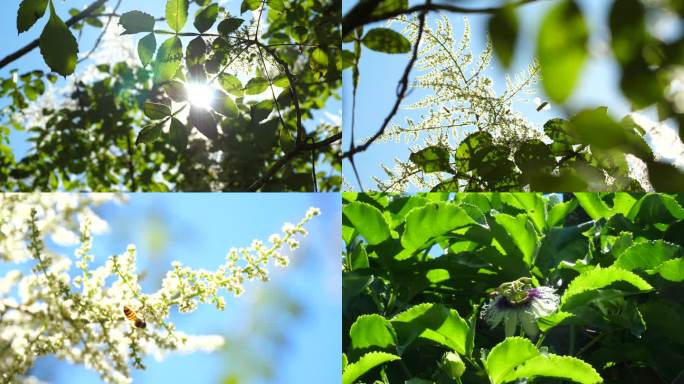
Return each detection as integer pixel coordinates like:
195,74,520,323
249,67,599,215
342,0,648,190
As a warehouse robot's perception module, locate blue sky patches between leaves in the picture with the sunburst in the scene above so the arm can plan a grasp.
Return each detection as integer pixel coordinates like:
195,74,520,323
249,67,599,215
0,0,342,177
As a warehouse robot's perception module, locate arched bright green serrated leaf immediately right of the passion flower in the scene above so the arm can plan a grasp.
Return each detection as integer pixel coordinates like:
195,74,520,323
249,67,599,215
561,266,653,310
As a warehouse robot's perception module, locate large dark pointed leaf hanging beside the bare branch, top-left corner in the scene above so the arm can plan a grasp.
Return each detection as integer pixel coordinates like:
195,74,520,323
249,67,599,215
38,3,78,77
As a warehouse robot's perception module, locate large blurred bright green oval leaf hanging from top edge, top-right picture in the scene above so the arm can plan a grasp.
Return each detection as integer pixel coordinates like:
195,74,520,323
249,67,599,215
537,0,589,104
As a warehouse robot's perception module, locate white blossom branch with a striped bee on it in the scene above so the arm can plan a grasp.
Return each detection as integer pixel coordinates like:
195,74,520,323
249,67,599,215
0,194,320,383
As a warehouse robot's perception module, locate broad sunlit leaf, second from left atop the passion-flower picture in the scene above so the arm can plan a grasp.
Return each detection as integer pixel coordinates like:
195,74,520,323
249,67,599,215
401,202,476,252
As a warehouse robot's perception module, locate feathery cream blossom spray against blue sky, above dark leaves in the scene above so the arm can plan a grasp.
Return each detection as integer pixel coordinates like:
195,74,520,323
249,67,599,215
373,15,545,192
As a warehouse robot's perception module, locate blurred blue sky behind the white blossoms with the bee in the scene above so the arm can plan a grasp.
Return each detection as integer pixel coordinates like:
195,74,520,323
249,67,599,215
0,193,342,384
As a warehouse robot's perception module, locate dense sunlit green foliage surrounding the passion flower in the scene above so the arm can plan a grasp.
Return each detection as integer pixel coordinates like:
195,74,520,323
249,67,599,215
342,192,684,383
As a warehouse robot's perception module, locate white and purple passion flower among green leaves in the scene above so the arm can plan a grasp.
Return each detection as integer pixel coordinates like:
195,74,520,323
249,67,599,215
480,277,560,338
